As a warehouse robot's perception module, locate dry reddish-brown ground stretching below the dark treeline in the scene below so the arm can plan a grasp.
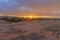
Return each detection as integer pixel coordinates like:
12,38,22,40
0,19,60,40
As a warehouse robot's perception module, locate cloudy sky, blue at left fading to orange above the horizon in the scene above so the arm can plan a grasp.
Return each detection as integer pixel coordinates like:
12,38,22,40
0,0,60,16
